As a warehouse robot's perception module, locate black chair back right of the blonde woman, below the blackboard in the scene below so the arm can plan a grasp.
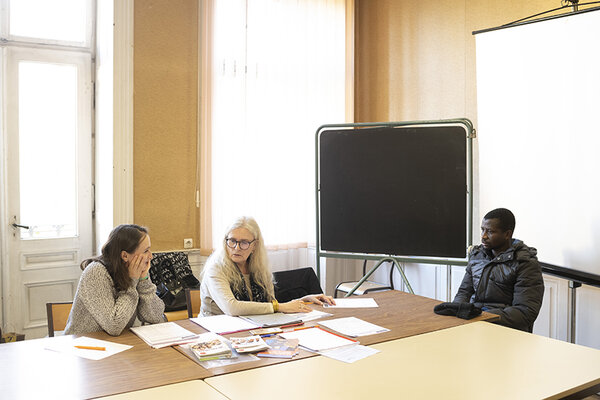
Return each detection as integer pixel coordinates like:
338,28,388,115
273,267,323,303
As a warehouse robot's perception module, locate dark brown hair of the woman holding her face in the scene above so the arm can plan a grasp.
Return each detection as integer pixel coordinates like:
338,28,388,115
81,224,148,292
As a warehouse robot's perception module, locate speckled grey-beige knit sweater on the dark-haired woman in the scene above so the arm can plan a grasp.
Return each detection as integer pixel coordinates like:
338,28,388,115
65,262,165,336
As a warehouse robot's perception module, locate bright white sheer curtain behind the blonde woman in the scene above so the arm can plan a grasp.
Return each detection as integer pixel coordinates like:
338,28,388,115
203,0,347,255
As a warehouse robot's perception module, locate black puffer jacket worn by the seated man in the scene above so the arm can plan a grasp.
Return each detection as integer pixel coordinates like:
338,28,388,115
454,239,544,332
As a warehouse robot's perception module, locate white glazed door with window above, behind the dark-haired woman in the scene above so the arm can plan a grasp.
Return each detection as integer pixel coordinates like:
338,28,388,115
0,0,95,338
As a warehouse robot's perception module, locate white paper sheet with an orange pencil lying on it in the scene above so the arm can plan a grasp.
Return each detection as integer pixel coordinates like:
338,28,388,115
45,336,133,360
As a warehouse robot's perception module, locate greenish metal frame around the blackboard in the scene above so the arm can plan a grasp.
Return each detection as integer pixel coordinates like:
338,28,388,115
315,118,475,276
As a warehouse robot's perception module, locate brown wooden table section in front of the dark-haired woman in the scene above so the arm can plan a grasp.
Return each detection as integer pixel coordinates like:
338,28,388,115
0,331,212,400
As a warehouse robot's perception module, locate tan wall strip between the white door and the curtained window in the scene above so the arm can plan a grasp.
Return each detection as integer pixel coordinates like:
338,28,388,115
133,0,200,251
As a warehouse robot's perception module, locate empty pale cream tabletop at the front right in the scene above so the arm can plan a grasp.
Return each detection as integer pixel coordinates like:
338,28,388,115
205,322,600,400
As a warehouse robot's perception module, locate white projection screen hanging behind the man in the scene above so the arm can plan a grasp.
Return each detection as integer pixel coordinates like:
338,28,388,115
476,10,600,274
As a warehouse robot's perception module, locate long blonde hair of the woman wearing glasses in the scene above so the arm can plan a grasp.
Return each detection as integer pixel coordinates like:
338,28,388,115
202,217,275,300
